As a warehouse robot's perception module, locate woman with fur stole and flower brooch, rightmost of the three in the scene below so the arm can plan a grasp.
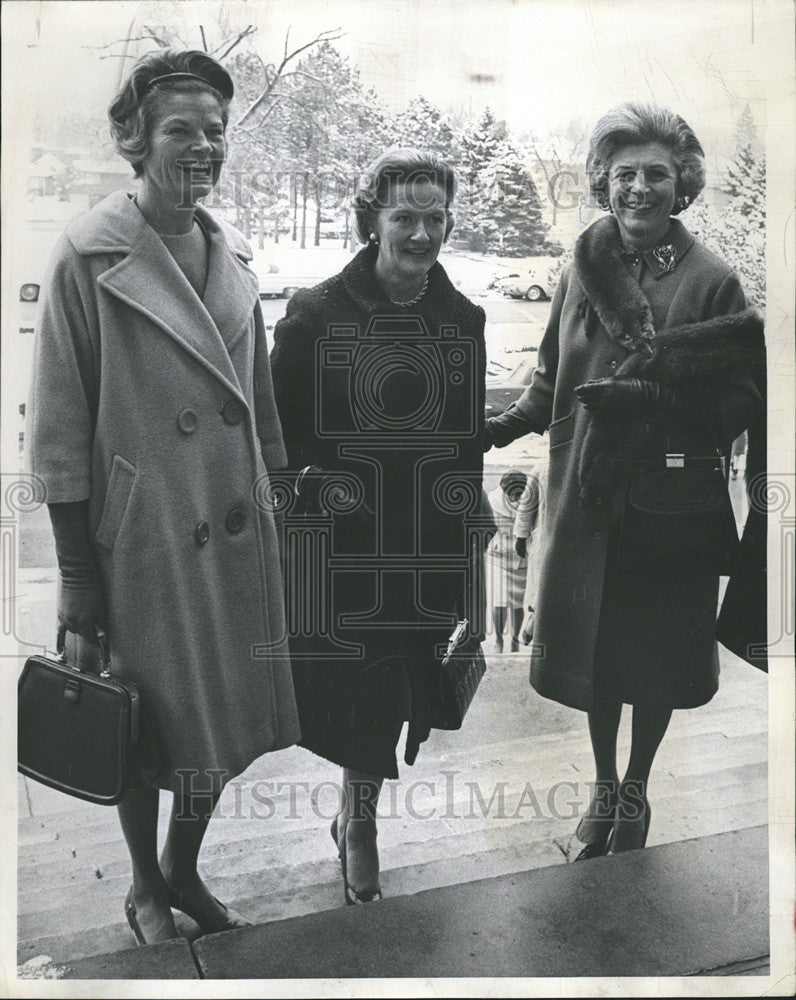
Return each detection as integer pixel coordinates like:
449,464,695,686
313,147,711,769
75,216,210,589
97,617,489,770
487,104,765,859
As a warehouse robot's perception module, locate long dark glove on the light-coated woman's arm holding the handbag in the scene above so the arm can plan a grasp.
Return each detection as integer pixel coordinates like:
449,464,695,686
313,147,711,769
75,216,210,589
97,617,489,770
47,500,105,644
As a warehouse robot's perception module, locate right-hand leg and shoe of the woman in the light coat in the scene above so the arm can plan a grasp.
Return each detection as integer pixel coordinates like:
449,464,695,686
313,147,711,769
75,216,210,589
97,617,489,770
160,793,248,932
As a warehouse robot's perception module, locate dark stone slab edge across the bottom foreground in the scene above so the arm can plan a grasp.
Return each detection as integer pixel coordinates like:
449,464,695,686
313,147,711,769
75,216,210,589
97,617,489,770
26,826,769,980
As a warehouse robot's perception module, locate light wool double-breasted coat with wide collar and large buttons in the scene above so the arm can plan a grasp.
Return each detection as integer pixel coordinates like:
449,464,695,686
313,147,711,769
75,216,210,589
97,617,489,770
28,192,299,791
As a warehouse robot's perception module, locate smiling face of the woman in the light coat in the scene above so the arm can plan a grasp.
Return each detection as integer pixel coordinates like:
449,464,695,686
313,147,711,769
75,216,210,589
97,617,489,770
142,91,227,214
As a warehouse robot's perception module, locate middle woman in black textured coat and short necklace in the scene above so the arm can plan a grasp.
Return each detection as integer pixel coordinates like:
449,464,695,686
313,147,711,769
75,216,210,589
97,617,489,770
271,149,494,903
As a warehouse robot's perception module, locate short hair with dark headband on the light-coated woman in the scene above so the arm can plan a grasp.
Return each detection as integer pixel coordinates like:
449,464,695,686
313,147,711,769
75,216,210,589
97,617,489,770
108,49,234,177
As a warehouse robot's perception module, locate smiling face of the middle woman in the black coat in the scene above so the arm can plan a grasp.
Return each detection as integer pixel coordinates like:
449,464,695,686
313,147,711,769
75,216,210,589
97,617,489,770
373,178,448,282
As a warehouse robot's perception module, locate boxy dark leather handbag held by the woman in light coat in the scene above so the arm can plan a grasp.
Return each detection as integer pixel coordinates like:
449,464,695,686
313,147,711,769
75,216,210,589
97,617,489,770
17,628,140,806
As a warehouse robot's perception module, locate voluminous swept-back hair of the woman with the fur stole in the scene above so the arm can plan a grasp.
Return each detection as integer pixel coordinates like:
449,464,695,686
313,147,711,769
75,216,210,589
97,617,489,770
586,102,705,215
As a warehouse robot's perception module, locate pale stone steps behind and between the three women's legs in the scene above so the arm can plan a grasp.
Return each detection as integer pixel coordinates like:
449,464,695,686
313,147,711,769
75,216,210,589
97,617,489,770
17,570,768,967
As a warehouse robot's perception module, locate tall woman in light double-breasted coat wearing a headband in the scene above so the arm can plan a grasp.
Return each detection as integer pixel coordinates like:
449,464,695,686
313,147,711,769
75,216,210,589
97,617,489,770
29,51,299,943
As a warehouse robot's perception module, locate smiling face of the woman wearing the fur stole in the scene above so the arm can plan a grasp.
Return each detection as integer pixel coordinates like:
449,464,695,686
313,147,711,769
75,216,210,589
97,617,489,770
608,142,678,250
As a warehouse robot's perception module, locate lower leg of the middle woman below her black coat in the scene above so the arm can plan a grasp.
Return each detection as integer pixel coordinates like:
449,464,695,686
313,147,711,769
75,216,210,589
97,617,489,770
337,767,384,896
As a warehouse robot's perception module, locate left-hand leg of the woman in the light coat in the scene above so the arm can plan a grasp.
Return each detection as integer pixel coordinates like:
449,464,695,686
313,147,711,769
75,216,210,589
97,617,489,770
117,788,178,944
